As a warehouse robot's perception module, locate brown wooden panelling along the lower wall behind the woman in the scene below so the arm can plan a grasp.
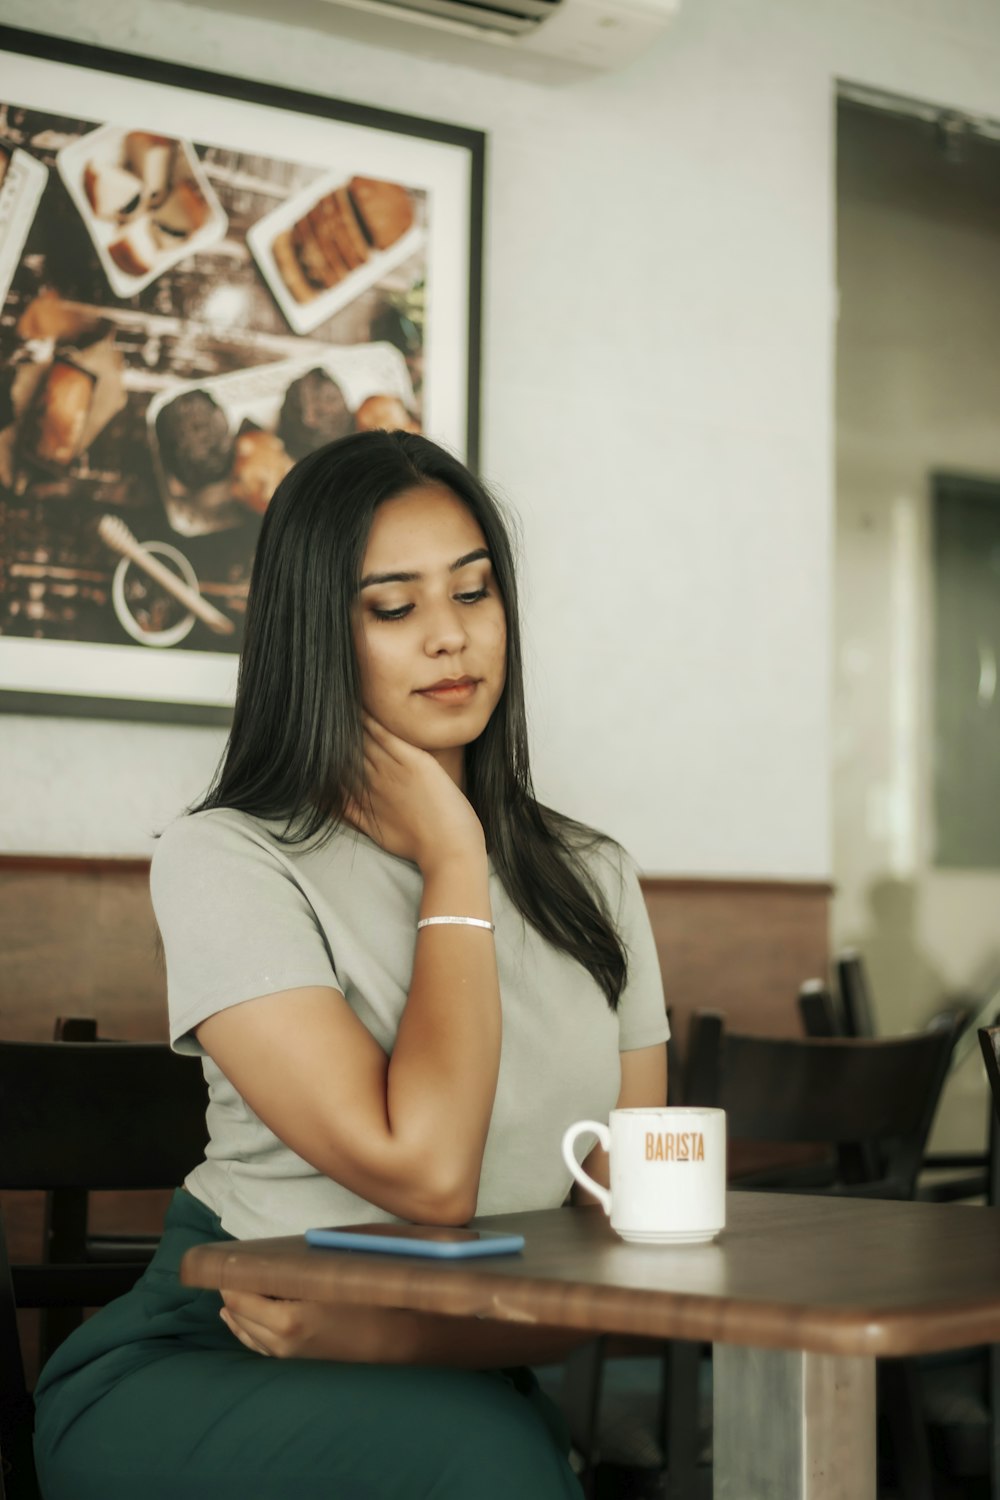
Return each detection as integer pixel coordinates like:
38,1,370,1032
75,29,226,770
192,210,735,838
0,855,831,1040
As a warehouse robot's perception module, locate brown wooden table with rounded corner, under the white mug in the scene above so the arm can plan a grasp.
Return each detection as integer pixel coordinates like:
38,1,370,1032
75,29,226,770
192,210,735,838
181,1193,1000,1500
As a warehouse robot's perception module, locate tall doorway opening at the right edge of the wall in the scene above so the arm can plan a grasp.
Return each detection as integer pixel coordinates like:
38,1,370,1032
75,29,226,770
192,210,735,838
832,87,1000,1149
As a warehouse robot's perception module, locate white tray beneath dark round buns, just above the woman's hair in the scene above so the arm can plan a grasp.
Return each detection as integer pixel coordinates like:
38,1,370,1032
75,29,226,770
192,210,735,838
145,344,414,537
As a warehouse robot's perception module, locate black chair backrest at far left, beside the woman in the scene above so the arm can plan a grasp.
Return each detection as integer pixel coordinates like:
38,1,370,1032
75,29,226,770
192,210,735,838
0,1041,207,1190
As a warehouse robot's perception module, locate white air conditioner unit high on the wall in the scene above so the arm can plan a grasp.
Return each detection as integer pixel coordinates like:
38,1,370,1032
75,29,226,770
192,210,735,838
314,0,681,80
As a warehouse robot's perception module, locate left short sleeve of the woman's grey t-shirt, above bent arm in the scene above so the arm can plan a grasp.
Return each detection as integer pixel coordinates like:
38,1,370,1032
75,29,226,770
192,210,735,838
150,810,340,1053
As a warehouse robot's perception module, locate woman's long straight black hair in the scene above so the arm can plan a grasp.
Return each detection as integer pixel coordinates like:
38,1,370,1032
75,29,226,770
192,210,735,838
192,432,627,1010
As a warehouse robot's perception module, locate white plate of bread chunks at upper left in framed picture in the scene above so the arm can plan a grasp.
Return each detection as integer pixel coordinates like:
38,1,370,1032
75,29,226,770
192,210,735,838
55,125,229,297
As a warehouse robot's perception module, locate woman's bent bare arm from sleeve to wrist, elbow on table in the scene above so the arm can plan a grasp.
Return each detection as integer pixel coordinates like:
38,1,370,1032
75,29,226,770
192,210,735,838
196,852,501,1224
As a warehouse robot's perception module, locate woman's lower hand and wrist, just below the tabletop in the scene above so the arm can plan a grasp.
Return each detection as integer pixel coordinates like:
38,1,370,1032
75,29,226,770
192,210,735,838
220,1292,406,1364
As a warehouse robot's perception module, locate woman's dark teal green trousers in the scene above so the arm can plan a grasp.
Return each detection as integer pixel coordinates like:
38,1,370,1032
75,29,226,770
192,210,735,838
34,1191,580,1500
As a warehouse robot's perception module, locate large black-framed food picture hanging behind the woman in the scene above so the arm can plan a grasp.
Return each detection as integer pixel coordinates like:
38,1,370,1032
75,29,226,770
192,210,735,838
0,27,484,723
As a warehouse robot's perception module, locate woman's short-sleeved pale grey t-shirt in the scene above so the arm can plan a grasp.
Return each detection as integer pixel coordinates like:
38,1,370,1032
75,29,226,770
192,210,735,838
151,809,669,1239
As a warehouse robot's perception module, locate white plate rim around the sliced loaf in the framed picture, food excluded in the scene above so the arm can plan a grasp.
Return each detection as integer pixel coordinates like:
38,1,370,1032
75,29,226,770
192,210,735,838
246,173,424,333
